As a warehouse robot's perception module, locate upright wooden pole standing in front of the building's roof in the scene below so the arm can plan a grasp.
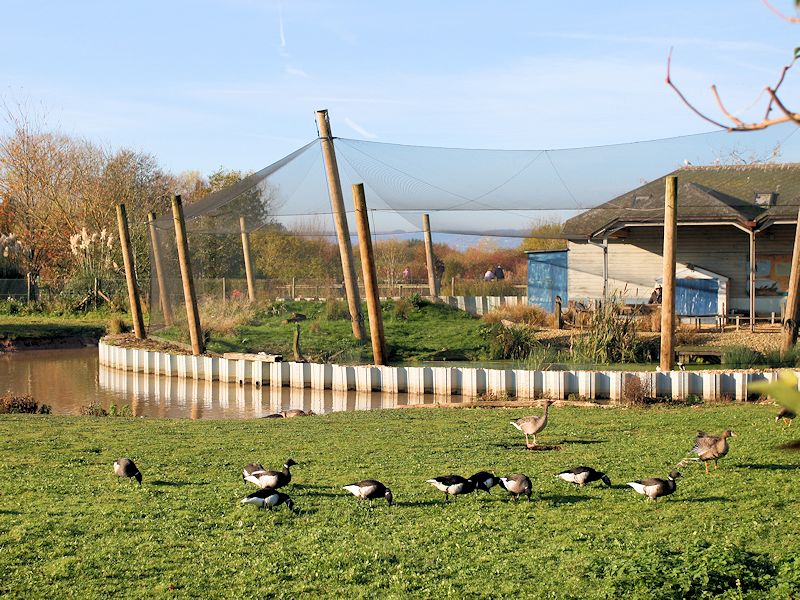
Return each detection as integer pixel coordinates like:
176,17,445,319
661,177,678,371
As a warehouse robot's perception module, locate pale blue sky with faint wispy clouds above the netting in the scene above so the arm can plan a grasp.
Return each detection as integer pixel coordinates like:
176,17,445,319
0,0,800,173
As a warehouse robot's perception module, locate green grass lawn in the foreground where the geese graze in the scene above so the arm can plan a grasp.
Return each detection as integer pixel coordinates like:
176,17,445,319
0,405,800,598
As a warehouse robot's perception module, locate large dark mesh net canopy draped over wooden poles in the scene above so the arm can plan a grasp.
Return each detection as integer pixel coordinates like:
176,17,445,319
150,119,800,340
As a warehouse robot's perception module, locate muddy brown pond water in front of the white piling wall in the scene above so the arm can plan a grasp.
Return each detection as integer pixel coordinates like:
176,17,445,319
0,348,458,419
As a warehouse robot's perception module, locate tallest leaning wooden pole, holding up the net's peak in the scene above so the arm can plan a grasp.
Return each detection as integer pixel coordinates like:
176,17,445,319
317,110,365,341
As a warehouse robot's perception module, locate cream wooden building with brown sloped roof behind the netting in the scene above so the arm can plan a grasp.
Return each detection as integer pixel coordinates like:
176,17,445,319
563,163,800,315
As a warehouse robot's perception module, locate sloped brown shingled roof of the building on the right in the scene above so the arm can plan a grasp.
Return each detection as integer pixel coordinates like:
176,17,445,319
562,163,800,239
